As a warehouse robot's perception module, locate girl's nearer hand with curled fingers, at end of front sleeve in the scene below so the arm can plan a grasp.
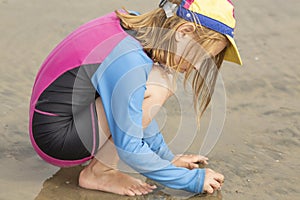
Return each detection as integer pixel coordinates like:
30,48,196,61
203,168,224,194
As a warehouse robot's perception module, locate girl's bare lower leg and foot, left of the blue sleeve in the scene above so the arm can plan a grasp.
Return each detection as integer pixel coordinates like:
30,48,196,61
79,98,156,196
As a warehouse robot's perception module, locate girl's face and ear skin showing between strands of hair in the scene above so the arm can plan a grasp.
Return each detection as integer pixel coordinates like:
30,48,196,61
175,40,228,73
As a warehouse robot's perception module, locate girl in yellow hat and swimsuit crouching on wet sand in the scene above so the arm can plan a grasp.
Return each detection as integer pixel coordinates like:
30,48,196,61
30,0,241,196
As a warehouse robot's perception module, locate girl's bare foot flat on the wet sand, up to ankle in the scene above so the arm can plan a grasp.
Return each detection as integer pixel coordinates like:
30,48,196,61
79,158,156,196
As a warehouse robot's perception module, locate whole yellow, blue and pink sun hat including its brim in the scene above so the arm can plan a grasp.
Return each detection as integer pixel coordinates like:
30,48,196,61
160,0,242,65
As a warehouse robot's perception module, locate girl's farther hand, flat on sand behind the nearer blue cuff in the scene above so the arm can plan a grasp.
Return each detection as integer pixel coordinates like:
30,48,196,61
172,155,208,169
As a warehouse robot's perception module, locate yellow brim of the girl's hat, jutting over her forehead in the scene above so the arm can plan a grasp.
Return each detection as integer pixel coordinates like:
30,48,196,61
224,35,243,65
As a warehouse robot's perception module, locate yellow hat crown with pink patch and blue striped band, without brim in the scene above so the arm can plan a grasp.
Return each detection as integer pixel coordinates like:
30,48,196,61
176,0,236,37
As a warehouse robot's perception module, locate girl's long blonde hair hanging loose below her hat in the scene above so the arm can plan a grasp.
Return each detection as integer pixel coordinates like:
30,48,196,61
116,0,227,125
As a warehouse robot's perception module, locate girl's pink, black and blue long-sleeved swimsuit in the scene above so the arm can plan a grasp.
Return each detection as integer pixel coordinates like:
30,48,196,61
29,13,205,193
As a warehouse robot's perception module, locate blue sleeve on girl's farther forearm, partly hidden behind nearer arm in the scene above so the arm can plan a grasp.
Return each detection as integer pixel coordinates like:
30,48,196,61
143,119,174,161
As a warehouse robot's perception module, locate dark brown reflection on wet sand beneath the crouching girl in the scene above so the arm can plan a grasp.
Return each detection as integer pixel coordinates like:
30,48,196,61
35,166,222,200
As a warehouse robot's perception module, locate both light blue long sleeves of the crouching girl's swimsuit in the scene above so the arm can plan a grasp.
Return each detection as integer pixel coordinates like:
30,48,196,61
92,36,205,193
